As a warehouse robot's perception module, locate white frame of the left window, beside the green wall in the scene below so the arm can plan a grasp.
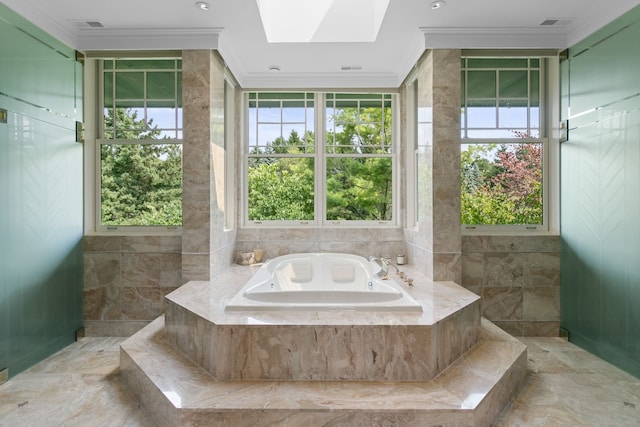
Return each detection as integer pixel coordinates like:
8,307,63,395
90,56,184,235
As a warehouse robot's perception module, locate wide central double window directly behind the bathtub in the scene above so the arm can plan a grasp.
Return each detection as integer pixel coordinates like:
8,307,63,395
245,92,396,226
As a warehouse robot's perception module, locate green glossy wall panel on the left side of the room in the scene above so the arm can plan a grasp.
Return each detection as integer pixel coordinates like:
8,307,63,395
0,4,83,376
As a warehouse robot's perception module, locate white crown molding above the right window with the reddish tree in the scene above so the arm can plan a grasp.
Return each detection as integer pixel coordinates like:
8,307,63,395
420,27,567,49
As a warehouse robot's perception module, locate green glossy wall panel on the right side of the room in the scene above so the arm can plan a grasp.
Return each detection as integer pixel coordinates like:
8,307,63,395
561,7,640,377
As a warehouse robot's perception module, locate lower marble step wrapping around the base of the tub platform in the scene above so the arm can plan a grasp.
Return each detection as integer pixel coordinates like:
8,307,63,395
120,317,526,427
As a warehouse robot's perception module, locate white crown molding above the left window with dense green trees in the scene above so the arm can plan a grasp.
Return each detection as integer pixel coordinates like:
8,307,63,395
78,28,224,50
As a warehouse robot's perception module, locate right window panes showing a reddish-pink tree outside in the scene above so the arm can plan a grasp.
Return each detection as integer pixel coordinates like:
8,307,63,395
461,57,548,230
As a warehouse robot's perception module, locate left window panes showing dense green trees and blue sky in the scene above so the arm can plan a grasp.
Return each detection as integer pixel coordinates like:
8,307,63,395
96,58,182,230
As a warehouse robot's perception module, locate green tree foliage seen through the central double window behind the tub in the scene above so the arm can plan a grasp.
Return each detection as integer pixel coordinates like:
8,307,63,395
248,102,393,221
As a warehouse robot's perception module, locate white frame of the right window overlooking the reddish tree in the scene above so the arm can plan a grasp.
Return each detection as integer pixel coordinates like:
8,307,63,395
460,51,559,235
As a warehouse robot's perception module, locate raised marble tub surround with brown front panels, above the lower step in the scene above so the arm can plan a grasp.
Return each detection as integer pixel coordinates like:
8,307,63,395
165,267,480,381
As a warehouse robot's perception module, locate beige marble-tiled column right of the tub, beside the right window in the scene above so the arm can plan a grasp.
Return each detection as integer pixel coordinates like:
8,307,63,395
406,49,462,283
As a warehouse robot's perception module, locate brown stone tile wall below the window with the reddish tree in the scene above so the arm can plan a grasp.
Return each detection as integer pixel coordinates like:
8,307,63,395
461,236,560,336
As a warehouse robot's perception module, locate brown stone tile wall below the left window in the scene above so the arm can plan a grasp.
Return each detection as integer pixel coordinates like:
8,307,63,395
84,236,184,336
